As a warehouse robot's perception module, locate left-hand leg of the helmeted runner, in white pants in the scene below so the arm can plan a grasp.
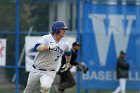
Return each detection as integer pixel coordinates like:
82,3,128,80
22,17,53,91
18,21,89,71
23,69,40,93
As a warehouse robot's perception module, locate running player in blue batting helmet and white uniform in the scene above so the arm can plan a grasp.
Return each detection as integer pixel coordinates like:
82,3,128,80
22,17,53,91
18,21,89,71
23,21,71,93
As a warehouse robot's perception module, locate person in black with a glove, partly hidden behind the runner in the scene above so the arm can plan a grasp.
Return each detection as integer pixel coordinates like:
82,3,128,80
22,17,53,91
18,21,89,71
54,41,88,93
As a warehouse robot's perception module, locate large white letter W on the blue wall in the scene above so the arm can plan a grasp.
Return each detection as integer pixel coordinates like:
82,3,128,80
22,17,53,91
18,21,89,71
89,14,136,66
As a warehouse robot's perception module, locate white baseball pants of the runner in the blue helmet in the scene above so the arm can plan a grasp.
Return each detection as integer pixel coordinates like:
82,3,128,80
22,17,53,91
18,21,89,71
23,68,56,93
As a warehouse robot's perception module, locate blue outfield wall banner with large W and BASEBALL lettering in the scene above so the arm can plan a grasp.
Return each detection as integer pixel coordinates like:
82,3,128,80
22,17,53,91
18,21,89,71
82,3,140,90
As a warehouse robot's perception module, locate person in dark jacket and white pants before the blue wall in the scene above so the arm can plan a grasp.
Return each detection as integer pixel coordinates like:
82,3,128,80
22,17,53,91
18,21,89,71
112,51,130,93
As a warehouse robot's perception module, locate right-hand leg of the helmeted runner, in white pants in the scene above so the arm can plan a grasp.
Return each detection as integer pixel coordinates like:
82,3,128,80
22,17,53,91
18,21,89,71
40,71,56,93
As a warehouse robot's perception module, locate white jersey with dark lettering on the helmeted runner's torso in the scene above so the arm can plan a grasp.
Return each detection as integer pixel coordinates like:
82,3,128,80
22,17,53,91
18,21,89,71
34,34,70,70
